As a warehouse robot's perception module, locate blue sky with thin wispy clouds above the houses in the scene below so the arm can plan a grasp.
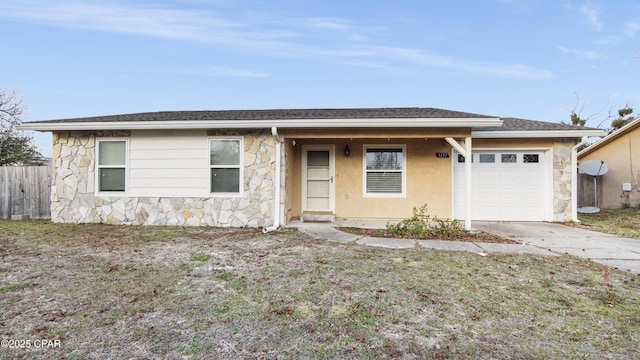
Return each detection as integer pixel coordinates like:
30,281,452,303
0,0,640,156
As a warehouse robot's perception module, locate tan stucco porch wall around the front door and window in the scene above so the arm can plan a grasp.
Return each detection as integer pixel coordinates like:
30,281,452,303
287,138,462,220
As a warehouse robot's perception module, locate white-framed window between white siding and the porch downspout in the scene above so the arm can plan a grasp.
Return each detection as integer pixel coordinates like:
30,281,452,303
209,139,243,194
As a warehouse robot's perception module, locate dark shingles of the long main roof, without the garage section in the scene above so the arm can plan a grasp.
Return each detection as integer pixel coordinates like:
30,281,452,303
28,107,498,123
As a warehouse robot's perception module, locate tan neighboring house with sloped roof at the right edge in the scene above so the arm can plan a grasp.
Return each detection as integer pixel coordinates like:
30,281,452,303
578,118,640,209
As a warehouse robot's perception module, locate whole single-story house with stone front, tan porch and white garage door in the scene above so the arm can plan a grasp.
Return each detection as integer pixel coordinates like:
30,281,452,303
21,108,604,230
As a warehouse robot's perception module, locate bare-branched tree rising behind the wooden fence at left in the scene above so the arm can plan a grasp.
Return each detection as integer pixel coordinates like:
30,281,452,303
0,89,45,166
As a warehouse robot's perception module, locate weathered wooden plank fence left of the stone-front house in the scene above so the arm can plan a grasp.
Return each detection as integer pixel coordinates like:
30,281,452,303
0,166,51,219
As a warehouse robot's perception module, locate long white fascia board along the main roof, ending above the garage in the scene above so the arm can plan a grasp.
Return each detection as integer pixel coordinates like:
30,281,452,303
18,118,502,131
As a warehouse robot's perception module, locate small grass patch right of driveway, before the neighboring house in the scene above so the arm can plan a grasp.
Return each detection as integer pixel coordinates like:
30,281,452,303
578,208,640,239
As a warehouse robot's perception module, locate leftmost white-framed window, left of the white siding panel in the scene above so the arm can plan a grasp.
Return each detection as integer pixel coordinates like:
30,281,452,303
98,140,127,192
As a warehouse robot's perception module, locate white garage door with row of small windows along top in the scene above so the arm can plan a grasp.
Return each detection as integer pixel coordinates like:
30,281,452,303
453,151,547,221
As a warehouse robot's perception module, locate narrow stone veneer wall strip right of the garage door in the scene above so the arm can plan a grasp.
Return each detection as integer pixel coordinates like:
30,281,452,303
553,139,577,222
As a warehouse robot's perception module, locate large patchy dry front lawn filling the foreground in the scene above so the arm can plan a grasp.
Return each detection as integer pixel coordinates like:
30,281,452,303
0,221,640,359
